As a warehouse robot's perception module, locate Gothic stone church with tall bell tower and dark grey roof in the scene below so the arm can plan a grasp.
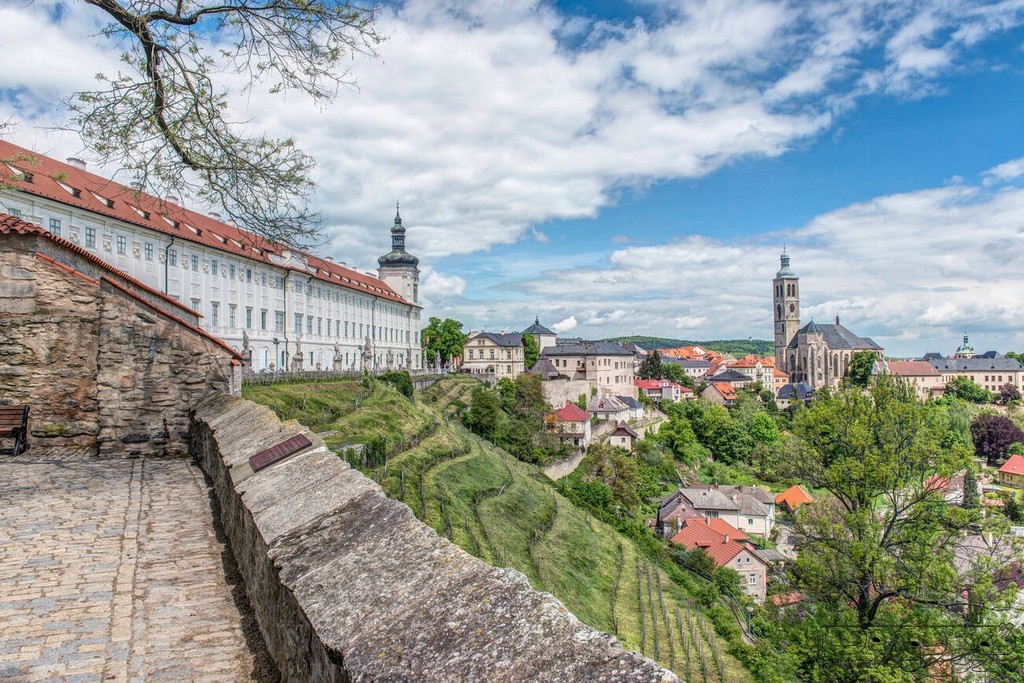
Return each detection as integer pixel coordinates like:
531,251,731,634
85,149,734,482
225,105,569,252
772,250,884,389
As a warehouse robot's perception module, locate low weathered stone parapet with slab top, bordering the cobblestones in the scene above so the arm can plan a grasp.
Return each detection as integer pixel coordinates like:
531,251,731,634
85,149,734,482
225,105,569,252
191,395,677,682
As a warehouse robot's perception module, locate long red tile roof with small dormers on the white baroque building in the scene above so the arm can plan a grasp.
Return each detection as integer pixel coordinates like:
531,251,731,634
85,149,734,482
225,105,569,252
0,140,416,306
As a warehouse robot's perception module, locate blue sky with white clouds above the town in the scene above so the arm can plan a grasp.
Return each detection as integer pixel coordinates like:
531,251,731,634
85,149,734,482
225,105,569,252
0,0,1024,357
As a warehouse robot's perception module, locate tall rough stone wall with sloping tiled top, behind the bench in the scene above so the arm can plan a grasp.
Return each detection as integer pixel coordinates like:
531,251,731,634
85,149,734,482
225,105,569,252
0,227,240,457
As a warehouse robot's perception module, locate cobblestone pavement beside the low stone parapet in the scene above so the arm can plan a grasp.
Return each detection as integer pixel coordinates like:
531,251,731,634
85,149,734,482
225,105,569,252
0,450,268,682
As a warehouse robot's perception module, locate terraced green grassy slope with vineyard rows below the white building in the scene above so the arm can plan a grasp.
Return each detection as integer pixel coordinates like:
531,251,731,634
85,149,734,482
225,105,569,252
243,376,751,683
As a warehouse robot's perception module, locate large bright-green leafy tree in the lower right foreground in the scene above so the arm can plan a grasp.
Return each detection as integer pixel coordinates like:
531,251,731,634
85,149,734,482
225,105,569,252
791,377,1012,682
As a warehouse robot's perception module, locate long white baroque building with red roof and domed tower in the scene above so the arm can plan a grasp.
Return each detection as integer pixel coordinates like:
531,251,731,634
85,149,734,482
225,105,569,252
0,140,423,372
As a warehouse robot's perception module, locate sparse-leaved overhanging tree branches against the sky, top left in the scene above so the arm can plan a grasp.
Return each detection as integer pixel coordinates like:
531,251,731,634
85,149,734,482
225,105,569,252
68,0,383,246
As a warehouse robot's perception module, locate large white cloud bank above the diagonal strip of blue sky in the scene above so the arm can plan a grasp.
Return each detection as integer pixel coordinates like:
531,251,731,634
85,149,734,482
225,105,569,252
0,0,1020,262
